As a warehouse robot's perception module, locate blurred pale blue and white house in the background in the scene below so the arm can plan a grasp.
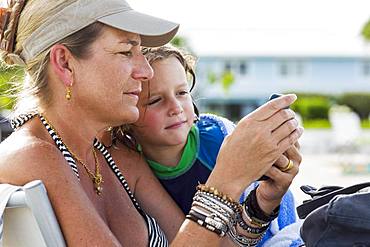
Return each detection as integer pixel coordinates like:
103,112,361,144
192,30,370,119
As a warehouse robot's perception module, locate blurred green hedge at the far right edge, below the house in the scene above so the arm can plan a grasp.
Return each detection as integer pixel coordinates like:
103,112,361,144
337,93,370,120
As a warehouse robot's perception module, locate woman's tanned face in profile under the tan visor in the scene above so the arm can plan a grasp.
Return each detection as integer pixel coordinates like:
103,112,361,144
72,27,153,126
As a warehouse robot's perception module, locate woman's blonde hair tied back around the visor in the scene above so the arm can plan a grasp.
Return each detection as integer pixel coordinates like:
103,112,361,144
0,0,104,116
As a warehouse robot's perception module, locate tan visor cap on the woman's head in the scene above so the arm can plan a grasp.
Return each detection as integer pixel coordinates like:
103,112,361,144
21,0,179,61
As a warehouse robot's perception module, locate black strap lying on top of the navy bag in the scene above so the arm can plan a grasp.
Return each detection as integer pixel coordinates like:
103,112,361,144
297,182,370,219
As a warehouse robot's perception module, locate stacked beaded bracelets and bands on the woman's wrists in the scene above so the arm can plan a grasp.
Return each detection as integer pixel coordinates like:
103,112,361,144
186,184,279,246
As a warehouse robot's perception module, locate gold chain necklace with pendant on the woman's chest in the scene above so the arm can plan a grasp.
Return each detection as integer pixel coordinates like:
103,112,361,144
42,116,104,196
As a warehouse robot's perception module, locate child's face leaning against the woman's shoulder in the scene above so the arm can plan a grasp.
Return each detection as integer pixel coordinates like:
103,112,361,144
132,57,195,150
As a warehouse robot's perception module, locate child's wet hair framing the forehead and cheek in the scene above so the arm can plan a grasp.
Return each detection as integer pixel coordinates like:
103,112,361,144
112,45,199,150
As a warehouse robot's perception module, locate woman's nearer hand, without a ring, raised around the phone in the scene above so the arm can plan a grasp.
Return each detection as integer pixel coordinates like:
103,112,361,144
207,94,303,200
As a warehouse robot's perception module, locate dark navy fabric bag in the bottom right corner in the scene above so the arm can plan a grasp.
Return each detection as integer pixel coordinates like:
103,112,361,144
300,192,370,247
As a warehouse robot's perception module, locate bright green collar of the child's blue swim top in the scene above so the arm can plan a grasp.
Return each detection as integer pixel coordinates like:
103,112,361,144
147,125,199,179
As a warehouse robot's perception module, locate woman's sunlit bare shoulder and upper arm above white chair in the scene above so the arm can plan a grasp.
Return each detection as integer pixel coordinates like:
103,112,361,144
0,133,118,243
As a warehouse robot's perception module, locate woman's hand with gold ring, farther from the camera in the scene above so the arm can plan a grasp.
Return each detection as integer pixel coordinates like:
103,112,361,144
257,143,302,214
